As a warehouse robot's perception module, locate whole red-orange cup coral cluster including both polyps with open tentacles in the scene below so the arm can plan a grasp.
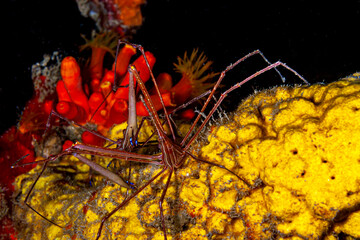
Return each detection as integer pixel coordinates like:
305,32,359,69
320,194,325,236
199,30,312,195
52,39,216,141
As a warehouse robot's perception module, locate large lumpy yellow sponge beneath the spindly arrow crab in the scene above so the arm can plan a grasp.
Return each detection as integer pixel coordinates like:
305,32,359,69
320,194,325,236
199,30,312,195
13,73,360,239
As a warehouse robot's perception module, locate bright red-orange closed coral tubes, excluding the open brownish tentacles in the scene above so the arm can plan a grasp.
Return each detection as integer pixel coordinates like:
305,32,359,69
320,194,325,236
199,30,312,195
52,42,162,133
